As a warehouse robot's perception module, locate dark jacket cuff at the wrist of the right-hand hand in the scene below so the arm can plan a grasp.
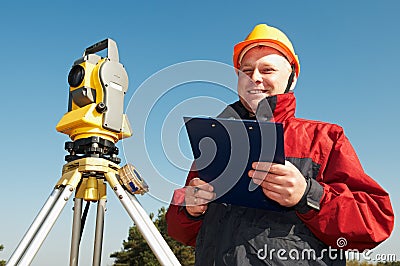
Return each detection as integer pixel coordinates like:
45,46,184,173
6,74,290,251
294,178,324,214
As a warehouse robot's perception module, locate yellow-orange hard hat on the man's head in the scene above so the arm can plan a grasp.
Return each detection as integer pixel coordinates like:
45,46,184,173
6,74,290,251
233,24,300,77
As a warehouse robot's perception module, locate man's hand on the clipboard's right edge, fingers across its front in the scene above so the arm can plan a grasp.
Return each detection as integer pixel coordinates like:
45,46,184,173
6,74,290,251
248,161,307,207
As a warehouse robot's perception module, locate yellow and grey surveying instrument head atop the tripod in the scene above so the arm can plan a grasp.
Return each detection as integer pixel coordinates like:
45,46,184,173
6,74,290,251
56,39,132,143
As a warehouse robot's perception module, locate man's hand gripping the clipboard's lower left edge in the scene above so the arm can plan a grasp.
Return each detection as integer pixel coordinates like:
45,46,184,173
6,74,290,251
185,177,215,216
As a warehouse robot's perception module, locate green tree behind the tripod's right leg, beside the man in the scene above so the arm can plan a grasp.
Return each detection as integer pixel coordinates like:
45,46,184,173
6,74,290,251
110,207,194,266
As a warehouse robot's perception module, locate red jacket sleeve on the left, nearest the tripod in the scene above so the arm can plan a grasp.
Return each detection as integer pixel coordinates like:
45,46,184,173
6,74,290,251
165,167,203,246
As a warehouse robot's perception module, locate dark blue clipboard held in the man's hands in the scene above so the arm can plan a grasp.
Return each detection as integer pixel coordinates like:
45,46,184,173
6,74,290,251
183,117,287,211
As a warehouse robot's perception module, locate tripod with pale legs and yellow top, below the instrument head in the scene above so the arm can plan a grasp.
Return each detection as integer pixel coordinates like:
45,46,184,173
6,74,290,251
7,137,180,266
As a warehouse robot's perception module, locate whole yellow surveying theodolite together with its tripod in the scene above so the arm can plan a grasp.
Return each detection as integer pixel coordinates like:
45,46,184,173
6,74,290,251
7,39,180,266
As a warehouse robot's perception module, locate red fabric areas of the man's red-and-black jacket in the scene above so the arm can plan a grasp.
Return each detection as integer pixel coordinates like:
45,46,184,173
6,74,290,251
166,93,394,254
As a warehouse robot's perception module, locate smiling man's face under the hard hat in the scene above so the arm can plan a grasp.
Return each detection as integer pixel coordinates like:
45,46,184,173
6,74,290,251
238,46,296,113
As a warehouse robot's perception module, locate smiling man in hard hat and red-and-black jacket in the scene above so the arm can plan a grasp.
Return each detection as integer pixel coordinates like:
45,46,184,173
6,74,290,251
167,24,394,265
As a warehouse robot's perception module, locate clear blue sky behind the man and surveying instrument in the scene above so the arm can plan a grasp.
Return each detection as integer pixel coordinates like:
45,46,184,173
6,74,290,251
0,0,400,265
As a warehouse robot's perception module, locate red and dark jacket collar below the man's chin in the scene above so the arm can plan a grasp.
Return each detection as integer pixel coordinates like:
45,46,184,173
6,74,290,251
218,92,296,123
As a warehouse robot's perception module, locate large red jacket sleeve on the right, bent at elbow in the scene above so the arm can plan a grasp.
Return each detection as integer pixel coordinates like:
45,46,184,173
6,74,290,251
298,130,394,250
